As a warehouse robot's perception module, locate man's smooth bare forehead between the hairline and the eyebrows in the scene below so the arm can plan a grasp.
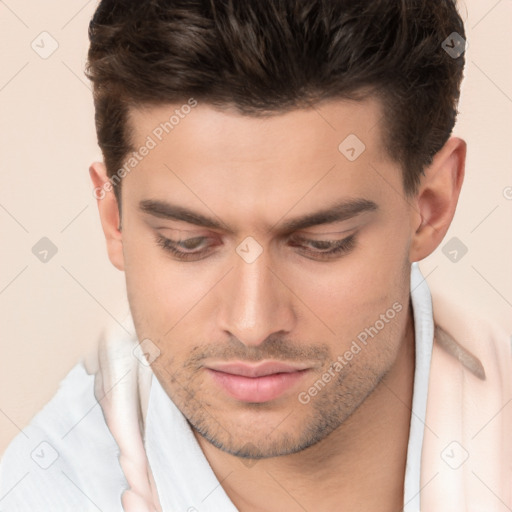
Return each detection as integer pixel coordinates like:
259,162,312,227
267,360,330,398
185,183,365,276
122,98,401,228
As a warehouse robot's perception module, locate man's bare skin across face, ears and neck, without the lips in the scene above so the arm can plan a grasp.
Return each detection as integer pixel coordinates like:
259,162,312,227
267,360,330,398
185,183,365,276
90,100,466,512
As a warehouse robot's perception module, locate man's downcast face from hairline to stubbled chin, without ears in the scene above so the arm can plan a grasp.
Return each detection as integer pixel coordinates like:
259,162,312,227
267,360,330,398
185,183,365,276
122,100,414,457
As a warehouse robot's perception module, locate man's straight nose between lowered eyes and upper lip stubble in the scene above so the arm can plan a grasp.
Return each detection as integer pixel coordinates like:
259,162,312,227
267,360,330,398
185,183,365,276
218,241,295,346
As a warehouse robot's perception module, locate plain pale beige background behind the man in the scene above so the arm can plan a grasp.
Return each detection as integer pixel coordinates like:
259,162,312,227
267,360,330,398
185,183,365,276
0,0,512,453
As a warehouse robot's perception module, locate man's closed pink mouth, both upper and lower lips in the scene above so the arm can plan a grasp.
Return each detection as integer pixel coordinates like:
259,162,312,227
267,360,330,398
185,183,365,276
205,361,311,403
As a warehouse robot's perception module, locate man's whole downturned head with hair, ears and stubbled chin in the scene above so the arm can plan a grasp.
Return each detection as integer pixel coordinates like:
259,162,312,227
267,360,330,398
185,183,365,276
88,0,465,457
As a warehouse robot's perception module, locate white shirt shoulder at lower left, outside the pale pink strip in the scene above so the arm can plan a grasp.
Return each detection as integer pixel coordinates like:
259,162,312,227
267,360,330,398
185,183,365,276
0,362,127,512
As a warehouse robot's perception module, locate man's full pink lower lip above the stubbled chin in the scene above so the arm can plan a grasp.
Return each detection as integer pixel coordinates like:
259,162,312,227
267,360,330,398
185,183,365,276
207,368,308,403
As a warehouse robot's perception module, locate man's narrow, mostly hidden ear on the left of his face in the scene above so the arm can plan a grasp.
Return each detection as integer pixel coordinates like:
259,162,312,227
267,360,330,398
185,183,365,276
89,162,124,270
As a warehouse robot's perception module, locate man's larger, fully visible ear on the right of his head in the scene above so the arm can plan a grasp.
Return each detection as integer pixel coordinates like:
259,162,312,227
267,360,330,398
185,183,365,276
409,137,466,262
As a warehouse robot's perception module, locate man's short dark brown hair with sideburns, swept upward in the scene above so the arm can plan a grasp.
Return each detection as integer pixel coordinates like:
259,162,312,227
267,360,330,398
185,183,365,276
85,0,465,204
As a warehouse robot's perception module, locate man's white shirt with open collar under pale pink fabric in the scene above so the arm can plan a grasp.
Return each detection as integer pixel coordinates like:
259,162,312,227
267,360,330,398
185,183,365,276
0,263,434,512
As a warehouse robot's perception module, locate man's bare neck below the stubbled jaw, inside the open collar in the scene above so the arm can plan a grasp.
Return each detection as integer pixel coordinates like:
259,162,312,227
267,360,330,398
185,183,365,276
194,308,415,512
